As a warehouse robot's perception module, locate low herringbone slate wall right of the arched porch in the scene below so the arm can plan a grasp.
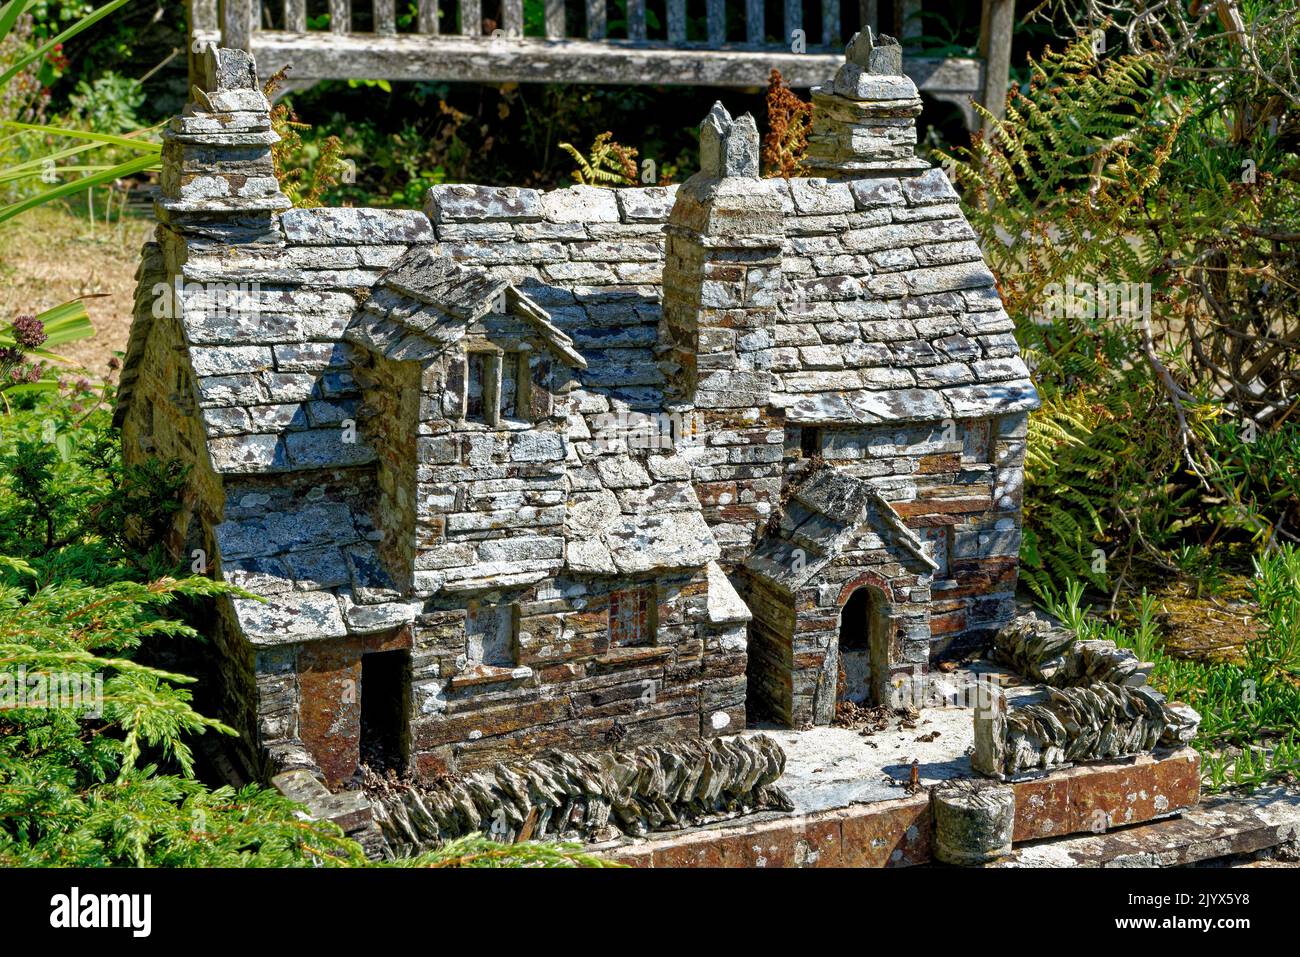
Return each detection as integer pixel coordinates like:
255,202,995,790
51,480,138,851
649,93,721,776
971,614,1201,780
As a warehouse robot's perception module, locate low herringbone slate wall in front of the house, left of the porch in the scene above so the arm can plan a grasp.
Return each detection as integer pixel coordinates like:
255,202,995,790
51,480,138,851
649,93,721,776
365,735,793,857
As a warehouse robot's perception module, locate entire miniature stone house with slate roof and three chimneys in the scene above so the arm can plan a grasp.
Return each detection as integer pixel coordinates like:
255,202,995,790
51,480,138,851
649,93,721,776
117,36,1037,785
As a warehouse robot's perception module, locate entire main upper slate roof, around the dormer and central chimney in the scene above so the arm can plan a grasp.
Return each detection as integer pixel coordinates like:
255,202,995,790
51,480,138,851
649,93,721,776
122,169,1037,473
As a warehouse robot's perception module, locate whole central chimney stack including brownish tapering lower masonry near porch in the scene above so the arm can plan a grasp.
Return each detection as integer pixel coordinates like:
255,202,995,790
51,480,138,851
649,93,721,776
659,103,784,564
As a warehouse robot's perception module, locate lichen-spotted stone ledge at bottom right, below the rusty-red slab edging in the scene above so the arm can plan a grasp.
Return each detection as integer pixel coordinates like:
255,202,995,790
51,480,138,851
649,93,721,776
985,788,1300,867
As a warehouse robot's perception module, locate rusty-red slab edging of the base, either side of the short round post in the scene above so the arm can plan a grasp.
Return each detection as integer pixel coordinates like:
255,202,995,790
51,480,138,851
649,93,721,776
602,749,1200,867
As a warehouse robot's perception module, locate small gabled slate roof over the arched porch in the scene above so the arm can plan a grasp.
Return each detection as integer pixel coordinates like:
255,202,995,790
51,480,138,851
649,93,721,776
745,468,939,592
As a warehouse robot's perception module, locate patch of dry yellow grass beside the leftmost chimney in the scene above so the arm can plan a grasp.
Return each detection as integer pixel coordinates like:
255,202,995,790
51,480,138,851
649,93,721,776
0,205,153,376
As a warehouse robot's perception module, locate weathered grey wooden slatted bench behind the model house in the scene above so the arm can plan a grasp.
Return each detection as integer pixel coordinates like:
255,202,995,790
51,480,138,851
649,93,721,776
190,0,1014,129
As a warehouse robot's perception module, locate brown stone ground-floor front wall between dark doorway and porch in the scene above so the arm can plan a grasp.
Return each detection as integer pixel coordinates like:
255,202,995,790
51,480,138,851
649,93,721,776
400,573,746,778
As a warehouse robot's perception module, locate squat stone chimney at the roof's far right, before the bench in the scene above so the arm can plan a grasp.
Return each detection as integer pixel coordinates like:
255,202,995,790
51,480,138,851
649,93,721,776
806,29,930,179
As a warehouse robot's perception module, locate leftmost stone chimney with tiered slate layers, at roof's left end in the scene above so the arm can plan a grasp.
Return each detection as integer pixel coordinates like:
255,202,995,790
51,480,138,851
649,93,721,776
156,47,293,242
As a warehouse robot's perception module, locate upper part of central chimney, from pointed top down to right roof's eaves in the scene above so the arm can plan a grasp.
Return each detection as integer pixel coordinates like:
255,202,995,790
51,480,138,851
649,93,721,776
659,103,784,408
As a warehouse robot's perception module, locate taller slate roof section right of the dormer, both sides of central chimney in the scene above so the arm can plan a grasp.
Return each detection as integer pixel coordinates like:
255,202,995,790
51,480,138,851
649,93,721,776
426,176,1037,424
